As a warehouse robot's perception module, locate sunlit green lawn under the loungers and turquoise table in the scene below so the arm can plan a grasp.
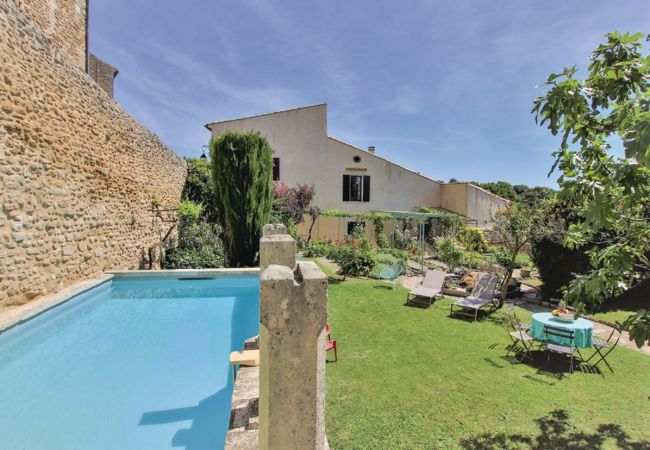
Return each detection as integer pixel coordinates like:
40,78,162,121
327,273,650,449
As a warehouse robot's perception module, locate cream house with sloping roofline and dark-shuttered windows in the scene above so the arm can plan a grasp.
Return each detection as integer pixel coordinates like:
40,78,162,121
206,104,509,239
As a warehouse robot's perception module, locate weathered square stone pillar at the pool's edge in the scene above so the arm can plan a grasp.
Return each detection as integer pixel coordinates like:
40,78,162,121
258,225,327,450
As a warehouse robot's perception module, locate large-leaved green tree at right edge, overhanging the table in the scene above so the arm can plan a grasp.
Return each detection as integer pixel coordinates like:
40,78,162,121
532,32,650,346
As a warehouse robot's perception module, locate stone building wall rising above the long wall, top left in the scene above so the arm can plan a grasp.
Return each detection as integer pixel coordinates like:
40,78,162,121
13,0,88,70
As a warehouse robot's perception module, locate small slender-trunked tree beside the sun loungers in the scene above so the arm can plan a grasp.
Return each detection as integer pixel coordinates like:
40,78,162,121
492,203,560,307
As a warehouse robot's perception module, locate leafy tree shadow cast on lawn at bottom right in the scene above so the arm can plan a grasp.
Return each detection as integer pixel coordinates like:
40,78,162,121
460,409,650,450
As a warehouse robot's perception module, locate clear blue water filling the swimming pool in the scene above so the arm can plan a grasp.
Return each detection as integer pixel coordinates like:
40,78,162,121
0,275,259,450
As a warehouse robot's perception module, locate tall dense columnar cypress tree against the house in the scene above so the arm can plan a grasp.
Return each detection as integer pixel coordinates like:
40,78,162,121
210,131,273,267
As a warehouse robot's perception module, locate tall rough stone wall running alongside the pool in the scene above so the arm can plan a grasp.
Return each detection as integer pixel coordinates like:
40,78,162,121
0,0,187,312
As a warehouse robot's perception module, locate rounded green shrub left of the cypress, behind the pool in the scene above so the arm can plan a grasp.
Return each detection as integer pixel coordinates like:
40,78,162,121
161,222,224,269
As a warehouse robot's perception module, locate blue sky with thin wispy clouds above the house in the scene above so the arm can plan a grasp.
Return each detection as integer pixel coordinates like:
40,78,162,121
90,0,650,186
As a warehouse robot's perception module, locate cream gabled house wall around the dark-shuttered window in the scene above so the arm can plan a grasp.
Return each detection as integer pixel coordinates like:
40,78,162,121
208,105,441,212
